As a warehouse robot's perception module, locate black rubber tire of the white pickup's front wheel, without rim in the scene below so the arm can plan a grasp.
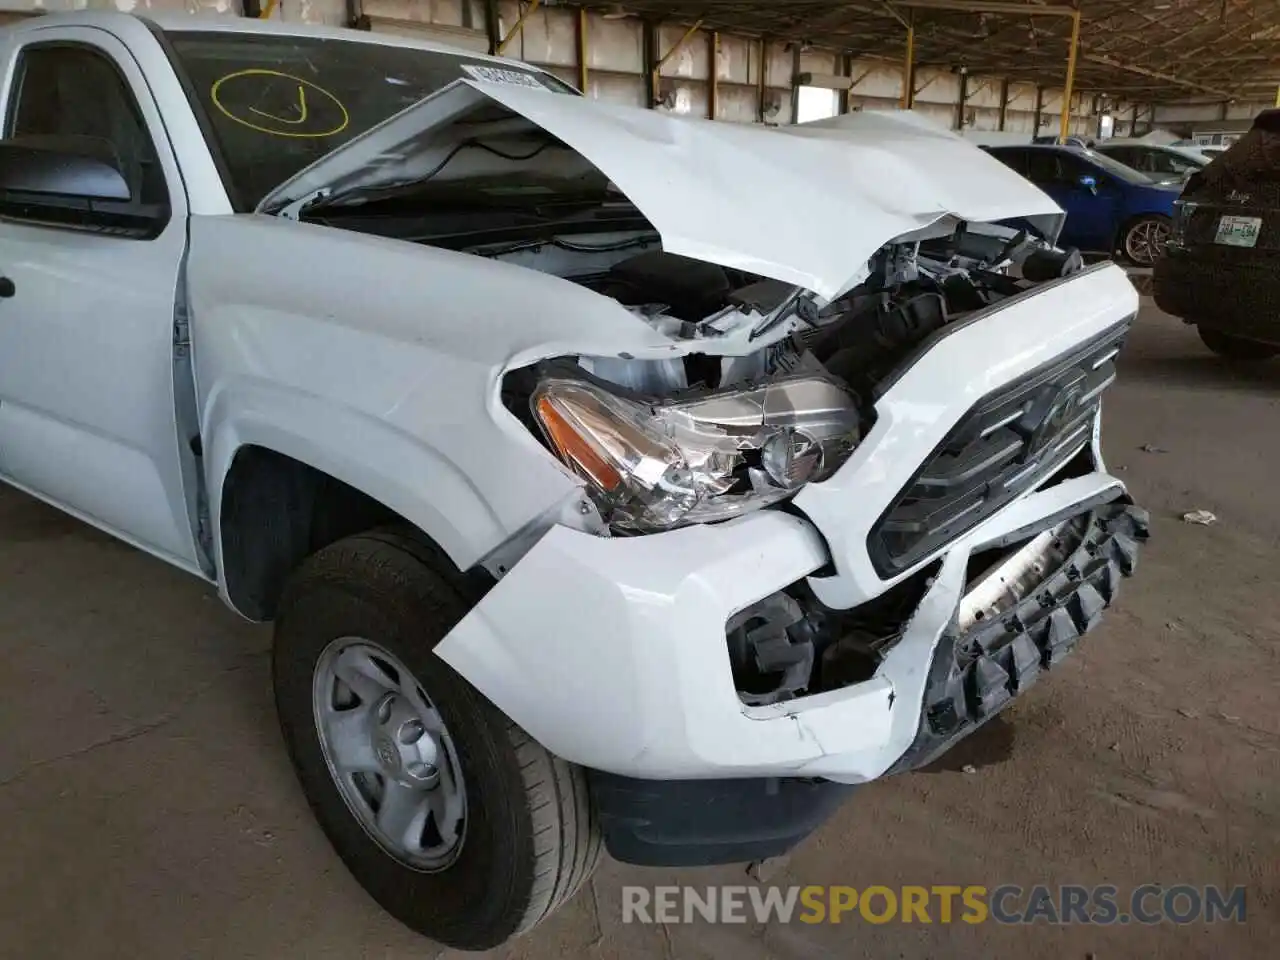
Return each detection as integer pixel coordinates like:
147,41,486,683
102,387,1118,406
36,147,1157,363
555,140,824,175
273,531,602,950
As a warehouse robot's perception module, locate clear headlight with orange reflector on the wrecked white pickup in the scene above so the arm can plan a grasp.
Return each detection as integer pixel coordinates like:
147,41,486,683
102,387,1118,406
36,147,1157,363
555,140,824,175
532,376,859,532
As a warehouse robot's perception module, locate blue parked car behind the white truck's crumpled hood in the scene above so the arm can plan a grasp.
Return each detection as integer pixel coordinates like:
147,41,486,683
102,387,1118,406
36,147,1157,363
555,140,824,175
987,143,1183,266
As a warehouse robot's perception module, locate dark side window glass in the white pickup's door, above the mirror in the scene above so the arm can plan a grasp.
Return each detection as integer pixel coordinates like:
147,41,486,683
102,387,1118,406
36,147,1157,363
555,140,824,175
5,42,169,220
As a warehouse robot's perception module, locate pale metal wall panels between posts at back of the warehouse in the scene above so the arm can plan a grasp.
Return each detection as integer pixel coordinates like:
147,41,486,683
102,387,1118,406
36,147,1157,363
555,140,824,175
0,0,1132,136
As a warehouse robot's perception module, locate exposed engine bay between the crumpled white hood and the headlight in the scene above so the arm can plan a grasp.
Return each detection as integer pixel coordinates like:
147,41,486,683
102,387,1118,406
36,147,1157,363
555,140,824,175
496,223,1083,407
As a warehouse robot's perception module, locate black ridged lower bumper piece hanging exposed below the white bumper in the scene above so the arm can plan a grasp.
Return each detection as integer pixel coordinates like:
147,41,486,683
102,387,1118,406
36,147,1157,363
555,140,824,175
888,498,1149,773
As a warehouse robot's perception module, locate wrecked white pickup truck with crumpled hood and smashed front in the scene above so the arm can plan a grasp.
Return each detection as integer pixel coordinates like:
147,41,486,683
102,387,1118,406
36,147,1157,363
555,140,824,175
0,13,1146,948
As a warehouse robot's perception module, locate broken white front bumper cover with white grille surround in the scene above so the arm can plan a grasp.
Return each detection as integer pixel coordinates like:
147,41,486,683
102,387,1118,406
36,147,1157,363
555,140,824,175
436,261,1137,782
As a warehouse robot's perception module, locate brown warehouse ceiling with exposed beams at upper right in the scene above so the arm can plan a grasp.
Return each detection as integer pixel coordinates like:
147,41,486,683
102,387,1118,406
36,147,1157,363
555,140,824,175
593,0,1280,101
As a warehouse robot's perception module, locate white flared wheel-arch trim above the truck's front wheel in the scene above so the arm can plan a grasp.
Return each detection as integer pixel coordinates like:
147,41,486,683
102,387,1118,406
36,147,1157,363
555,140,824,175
202,381,506,591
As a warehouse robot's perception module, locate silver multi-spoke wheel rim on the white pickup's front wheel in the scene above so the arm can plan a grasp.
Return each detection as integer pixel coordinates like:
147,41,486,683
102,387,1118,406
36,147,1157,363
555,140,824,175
312,636,467,870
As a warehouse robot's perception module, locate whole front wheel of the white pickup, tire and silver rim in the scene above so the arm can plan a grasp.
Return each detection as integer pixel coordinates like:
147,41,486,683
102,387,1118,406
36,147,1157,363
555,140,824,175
273,531,600,950
